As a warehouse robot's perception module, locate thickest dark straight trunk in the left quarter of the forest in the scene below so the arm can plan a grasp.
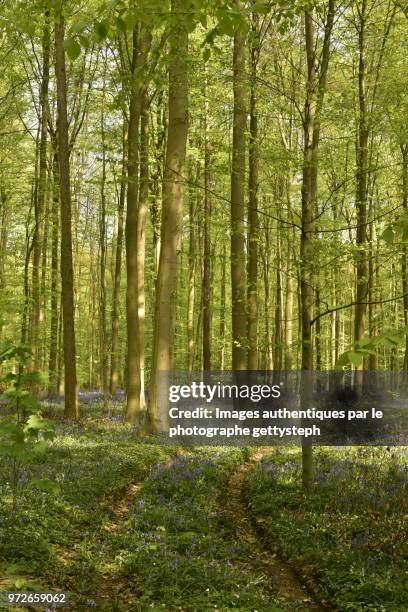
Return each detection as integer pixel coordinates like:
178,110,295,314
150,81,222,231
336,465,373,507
55,3,79,419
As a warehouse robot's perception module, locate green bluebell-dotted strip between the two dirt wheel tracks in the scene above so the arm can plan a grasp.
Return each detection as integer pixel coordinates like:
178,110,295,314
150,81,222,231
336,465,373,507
103,448,280,612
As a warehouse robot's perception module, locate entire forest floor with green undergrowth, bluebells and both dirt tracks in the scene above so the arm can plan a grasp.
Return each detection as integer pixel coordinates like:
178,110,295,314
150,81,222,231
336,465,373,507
0,402,408,612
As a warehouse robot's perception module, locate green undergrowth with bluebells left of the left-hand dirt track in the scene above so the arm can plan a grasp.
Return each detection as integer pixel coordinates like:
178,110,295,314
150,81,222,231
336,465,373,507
0,408,176,604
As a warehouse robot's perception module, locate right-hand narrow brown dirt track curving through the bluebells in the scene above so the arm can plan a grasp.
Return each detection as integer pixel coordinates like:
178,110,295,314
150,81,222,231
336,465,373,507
222,449,329,612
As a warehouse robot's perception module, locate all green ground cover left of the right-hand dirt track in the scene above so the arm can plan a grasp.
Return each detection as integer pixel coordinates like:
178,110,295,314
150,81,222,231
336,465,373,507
0,404,280,612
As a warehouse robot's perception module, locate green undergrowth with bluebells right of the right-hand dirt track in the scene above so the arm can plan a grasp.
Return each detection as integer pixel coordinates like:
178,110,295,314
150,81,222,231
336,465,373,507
246,447,408,612
